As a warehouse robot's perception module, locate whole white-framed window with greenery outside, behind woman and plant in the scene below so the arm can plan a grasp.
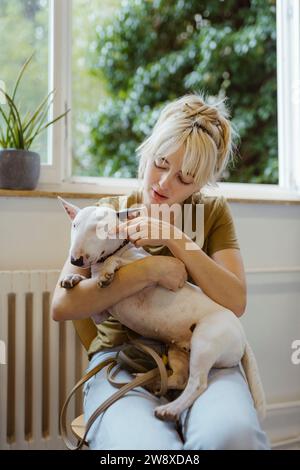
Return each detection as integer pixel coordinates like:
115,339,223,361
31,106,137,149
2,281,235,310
0,0,300,192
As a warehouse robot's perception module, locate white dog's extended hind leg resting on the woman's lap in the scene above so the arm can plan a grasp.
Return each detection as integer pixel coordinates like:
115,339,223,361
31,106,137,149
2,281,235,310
155,319,222,421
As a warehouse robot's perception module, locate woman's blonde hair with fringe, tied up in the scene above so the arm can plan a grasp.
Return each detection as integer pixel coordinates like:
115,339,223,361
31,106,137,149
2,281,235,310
136,93,237,188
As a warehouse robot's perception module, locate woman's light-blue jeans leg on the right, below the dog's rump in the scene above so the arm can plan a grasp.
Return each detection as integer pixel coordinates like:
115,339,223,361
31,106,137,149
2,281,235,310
180,366,270,450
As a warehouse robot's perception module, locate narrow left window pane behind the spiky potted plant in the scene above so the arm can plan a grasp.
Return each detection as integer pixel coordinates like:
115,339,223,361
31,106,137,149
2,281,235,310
0,0,49,164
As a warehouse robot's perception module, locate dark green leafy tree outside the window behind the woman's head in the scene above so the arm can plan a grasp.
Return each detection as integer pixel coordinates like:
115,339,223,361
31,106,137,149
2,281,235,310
89,0,278,183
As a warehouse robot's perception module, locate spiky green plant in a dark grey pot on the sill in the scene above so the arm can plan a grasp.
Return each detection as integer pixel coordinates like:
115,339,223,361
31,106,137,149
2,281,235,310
0,55,70,189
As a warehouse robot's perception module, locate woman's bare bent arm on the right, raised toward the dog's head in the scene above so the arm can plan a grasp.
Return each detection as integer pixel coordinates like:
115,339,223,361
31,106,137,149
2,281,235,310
168,237,247,317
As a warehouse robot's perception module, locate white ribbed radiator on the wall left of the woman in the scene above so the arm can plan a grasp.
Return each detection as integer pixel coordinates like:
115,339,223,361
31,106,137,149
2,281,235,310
0,270,87,449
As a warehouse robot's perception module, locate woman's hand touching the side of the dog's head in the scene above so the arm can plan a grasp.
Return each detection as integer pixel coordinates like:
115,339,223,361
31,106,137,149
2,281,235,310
108,215,182,247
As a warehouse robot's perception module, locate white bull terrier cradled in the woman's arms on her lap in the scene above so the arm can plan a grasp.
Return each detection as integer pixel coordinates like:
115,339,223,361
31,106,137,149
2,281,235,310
59,198,265,421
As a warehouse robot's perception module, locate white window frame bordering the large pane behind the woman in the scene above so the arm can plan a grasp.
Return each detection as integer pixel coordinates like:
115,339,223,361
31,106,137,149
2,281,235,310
40,0,300,199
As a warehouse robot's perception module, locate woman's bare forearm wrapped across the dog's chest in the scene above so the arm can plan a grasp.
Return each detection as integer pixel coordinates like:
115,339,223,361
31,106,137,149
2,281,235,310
51,256,187,321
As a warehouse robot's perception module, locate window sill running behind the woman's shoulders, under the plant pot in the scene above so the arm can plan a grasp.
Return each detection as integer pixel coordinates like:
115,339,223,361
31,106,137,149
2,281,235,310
0,178,300,204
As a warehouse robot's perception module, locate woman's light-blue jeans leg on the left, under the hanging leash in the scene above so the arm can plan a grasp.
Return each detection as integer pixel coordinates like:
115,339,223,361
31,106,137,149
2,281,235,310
84,346,182,450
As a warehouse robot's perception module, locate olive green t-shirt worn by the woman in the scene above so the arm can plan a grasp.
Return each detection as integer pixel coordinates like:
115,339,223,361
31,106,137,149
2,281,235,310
88,189,239,357
